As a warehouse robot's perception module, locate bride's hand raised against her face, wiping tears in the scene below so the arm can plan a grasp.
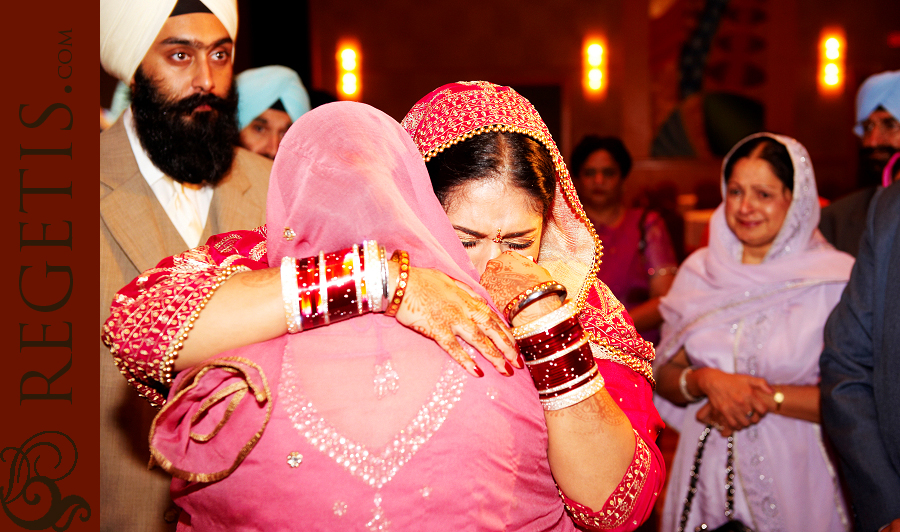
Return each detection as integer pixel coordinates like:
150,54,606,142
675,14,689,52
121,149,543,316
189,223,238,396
481,251,561,325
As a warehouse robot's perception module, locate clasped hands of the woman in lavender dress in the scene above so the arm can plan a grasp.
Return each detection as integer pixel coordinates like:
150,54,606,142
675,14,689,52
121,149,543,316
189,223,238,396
694,368,774,435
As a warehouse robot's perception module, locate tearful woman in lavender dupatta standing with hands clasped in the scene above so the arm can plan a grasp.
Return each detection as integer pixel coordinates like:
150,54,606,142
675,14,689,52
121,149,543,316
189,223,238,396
654,133,853,532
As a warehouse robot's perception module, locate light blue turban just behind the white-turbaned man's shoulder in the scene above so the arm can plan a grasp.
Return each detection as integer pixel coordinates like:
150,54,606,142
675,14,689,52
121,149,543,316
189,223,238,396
235,65,310,129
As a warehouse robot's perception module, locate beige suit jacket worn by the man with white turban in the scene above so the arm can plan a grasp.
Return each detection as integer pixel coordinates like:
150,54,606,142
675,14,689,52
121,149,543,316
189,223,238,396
97,120,272,532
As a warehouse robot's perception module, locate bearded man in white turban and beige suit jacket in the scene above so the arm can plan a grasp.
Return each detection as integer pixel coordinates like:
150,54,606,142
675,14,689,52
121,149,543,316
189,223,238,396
100,0,271,532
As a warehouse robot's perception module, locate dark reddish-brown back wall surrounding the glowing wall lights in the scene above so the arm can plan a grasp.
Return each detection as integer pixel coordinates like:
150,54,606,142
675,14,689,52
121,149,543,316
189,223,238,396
309,0,900,202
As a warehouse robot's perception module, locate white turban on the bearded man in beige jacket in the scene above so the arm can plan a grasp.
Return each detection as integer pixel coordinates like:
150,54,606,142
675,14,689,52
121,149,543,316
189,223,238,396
100,0,237,84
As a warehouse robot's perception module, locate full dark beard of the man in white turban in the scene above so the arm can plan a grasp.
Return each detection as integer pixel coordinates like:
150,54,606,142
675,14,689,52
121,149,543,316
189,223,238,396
131,68,239,185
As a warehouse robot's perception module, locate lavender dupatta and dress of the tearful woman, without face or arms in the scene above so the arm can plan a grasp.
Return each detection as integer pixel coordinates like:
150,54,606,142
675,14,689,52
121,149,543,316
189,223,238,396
654,133,853,532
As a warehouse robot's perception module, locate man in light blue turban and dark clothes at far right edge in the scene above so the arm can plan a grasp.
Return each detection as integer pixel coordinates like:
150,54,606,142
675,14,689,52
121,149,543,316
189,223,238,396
819,70,900,257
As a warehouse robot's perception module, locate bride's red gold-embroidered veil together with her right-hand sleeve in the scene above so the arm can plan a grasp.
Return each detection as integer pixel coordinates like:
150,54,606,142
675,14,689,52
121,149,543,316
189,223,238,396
402,81,665,530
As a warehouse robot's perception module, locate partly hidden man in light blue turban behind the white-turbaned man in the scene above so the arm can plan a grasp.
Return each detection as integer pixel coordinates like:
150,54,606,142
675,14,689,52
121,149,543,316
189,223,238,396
235,65,310,159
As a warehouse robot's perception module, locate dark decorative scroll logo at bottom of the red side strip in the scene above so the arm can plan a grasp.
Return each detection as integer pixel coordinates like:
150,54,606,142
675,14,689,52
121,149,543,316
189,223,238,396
0,431,91,531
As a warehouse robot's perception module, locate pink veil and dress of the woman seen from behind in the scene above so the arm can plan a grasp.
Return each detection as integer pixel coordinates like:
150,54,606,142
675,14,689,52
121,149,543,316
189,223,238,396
143,102,573,531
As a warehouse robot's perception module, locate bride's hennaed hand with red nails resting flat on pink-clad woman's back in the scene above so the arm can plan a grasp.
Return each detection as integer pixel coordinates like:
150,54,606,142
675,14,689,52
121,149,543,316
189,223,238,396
398,262,523,377
